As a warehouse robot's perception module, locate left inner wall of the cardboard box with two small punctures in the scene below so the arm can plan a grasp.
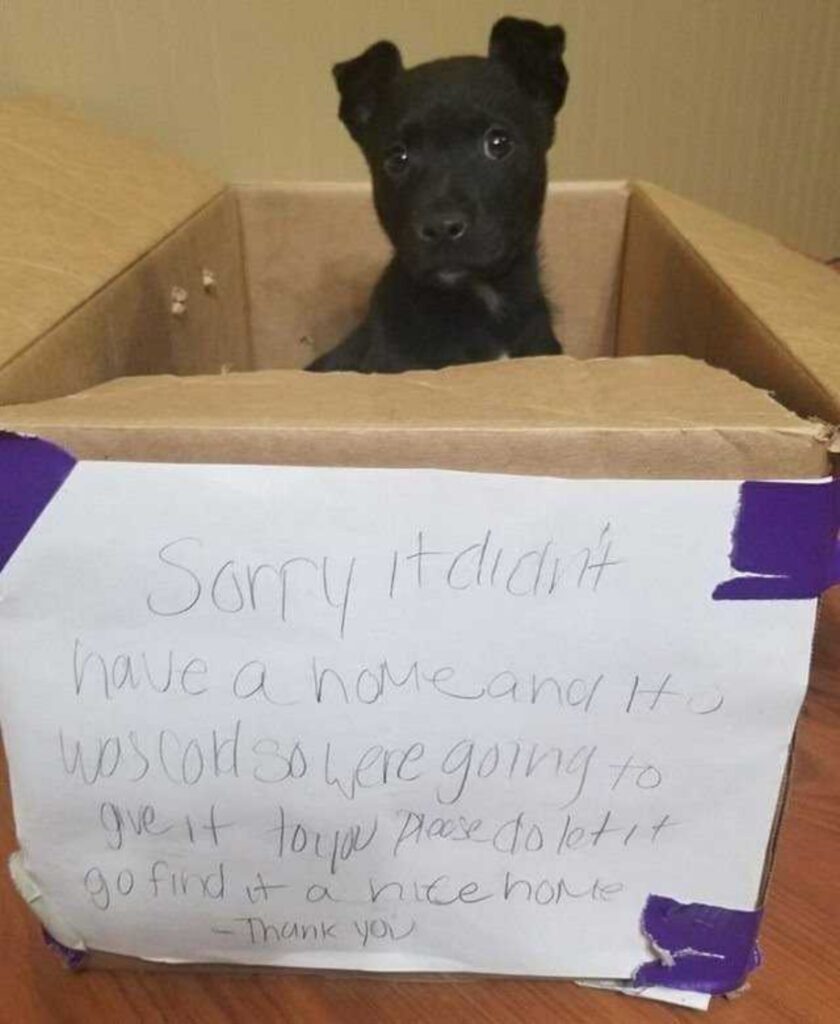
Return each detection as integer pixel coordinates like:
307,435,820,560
0,193,251,403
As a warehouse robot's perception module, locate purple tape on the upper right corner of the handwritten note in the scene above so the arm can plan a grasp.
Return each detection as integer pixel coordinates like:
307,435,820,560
712,479,840,601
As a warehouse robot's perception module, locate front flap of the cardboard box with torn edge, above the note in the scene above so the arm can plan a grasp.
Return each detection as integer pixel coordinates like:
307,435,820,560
0,356,828,478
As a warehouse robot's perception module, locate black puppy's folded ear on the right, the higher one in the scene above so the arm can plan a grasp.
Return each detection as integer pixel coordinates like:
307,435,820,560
490,17,569,118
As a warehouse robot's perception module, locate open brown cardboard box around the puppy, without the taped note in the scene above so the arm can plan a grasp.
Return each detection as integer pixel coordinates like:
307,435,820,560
0,100,840,987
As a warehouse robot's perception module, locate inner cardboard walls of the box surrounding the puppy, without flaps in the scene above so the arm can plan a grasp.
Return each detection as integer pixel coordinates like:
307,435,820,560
0,176,831,436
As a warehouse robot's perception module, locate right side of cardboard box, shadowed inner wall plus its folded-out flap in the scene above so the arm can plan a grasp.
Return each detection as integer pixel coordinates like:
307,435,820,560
617,184,840,423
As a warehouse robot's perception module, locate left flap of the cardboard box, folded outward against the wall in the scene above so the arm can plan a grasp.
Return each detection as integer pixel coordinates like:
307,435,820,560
0,98,222,367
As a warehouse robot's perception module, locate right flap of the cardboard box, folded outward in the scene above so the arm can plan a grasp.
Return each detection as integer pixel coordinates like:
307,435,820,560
634,182,840,424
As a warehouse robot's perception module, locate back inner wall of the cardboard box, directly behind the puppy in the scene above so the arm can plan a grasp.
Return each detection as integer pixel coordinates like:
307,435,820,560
236,182,629,369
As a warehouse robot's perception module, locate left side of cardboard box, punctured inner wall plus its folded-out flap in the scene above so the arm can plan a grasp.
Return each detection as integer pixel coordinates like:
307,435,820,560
0,100,250,403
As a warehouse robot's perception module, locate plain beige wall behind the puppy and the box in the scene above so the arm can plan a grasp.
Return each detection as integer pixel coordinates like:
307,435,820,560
0,0,840,256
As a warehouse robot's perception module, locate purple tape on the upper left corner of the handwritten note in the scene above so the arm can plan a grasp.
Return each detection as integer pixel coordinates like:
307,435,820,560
0,431,76,569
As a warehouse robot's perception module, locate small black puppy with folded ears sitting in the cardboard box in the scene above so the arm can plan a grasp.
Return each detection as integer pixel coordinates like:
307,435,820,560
307,17,569,373
